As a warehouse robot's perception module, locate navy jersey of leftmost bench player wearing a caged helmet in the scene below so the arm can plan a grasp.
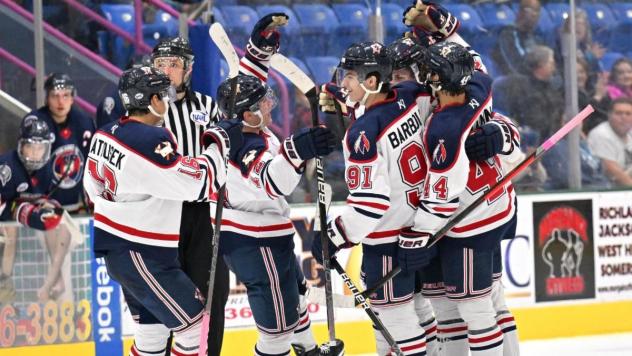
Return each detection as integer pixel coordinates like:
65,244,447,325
0,150,51,221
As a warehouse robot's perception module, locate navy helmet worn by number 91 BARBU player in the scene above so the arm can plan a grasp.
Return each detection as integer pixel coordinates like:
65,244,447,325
338,41,393,87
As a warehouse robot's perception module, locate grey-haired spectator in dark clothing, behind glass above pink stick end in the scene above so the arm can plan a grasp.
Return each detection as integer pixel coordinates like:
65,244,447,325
496,45,564,144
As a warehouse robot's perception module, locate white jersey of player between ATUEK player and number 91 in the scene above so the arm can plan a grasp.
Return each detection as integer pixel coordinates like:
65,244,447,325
218,129,302,238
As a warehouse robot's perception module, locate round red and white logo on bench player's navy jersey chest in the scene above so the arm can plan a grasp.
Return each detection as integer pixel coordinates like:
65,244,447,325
52,144,85,189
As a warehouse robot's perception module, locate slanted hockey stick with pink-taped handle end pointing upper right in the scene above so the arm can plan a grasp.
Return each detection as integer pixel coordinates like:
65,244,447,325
362,105,595,297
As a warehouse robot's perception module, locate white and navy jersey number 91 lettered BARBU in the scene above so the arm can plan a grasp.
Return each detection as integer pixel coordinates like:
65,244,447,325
333,82,428,245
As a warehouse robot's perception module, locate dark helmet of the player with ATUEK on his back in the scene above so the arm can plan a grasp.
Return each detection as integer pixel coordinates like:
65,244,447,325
118,67,171,111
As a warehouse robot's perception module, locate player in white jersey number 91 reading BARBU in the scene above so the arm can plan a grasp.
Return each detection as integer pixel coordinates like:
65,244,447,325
312,42,429,355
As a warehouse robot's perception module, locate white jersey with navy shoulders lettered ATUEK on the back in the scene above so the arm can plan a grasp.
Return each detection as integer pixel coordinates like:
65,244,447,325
84,117,226,250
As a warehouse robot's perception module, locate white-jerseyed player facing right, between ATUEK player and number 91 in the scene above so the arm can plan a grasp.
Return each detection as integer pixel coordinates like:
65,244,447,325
217,71,334,356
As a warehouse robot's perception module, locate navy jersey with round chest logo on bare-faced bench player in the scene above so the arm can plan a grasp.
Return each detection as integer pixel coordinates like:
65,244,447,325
27,106,95,211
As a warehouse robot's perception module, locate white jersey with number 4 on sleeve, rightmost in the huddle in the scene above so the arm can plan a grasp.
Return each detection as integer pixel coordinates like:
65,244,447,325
413,72,516,237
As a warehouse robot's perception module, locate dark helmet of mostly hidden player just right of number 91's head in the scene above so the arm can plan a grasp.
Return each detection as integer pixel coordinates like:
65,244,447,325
387,37,428,82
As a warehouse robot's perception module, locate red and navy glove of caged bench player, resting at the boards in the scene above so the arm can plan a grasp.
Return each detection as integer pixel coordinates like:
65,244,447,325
15,199,64,231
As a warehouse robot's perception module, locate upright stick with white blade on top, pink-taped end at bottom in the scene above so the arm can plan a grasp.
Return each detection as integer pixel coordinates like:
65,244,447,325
198,22,239,356
